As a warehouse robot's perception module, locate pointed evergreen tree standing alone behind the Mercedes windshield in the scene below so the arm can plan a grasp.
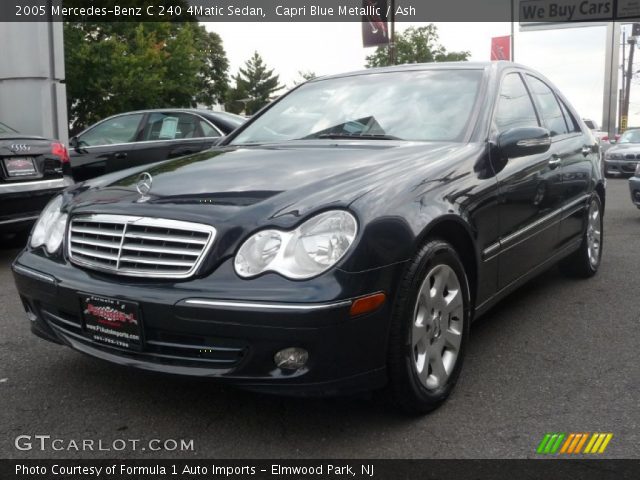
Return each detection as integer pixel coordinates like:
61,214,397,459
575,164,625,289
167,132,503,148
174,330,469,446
226,52,284,115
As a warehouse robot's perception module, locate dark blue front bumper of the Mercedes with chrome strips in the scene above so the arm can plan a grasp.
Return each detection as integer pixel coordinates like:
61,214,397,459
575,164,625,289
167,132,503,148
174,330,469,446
13,251,403,395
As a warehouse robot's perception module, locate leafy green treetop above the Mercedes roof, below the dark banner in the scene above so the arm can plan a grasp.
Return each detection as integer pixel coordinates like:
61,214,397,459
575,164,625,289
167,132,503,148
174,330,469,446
366,23,471,68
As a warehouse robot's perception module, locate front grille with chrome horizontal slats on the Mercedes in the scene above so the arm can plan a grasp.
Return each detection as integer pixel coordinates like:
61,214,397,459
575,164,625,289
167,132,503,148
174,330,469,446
67,215,216,278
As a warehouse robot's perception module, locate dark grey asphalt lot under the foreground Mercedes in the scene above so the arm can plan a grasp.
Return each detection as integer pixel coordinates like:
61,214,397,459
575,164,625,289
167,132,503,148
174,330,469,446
0,179,640,458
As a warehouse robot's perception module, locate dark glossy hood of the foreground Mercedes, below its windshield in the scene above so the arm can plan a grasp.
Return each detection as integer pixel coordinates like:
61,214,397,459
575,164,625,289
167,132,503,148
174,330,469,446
70,141,478,224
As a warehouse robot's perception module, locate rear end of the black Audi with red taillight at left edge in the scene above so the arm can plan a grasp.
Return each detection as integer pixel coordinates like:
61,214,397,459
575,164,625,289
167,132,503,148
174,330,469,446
0,123,73,233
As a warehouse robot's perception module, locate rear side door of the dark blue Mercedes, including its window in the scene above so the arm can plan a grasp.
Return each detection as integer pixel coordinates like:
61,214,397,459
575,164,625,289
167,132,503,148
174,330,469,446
527,74,598,248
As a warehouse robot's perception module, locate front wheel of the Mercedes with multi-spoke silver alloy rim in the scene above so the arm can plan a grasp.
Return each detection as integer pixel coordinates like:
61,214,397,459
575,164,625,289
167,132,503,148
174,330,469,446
388,240,470,415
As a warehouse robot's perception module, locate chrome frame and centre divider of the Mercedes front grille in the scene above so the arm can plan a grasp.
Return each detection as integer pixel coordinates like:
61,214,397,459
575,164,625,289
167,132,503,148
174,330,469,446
65,214,217,279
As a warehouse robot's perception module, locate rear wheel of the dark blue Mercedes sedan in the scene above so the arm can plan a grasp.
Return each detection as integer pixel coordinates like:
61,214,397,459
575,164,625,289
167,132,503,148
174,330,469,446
560,194,604,278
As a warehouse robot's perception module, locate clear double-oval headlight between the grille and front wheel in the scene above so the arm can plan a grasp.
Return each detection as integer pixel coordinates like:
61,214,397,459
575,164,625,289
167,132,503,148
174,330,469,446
234,210,358,280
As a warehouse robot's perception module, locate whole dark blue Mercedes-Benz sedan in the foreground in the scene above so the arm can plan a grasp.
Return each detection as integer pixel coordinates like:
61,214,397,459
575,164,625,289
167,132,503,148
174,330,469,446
13,62,605,412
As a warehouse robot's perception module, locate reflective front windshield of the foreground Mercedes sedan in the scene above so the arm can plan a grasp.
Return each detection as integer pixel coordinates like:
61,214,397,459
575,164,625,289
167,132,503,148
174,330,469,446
230,69,483,145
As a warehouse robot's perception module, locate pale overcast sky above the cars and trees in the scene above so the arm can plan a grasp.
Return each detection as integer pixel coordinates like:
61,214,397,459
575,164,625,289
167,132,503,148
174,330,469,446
205,22,640,125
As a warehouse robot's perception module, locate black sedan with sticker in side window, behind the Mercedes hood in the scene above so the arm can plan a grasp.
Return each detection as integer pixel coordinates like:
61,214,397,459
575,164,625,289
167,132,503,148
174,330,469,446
69,109,245,182
